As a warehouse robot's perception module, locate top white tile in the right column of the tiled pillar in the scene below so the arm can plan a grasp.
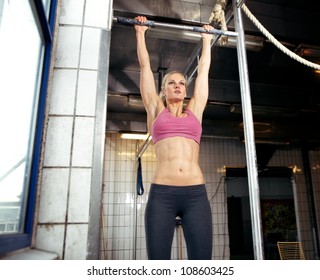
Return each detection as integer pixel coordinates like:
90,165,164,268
84,0,112,28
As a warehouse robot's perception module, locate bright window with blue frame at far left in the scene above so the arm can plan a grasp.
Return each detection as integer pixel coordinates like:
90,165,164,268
0,0,56,255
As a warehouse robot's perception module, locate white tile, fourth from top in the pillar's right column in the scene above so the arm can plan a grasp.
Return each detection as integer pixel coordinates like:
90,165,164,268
72,117,94,167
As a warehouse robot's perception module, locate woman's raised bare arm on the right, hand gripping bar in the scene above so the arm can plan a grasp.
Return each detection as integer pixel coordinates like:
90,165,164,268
188,25,213,122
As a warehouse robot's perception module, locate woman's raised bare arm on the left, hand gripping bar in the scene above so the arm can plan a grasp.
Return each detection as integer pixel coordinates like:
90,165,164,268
135,16,163,131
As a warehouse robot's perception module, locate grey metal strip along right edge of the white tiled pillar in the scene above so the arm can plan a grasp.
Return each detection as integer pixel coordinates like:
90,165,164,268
86,0,113,260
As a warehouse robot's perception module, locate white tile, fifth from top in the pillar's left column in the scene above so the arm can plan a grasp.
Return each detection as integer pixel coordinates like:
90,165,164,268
38,168,69,223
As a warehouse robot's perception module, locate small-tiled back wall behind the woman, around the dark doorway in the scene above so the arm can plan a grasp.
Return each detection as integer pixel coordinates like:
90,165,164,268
101,134,320,260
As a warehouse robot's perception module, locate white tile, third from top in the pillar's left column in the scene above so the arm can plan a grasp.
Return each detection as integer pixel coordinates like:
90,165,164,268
49,69,77,115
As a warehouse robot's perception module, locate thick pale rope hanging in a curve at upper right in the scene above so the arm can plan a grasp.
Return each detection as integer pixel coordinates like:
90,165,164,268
241,4,320,70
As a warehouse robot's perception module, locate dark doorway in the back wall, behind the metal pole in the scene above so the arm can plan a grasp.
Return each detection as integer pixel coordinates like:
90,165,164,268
226,167,297,260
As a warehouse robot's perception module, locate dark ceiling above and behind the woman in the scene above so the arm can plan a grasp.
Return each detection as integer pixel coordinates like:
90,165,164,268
107,0,320,148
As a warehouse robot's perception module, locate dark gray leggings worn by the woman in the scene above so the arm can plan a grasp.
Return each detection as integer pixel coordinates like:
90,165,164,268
145,184,212,260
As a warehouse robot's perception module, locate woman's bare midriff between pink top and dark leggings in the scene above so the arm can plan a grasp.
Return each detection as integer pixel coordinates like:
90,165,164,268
152,136,204,186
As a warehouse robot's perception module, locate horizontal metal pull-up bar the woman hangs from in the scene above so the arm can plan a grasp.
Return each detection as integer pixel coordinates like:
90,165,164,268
113,17,238,37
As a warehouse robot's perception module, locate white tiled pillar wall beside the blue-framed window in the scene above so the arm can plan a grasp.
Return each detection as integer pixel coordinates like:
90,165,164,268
33,0,112,259
